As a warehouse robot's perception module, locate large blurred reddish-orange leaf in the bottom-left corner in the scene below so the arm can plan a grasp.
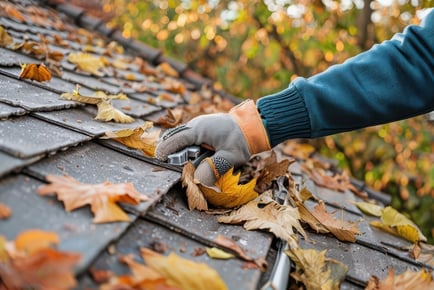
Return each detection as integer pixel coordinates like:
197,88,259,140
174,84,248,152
0,248,80,290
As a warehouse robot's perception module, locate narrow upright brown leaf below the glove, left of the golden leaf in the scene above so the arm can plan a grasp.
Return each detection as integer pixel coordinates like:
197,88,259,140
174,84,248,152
181,161,208,210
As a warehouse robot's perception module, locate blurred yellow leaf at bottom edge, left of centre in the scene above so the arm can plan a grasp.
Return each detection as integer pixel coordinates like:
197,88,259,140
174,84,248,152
140,248,228,290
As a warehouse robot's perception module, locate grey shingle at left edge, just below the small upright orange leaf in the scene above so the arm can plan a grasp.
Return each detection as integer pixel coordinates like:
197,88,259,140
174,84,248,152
0,74,76,111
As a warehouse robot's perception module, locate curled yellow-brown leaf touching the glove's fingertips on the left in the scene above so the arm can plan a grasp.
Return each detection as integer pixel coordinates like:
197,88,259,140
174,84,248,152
101,122,160,157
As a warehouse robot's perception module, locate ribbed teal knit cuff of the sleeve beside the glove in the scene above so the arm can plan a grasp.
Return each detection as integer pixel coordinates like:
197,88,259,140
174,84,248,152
256,84,311,147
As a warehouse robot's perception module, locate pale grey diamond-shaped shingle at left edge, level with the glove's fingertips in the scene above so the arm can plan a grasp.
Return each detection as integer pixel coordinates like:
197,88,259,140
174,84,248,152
0,116,90,158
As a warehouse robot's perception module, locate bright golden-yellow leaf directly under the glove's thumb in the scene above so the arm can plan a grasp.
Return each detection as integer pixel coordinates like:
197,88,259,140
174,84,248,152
199,167,258,208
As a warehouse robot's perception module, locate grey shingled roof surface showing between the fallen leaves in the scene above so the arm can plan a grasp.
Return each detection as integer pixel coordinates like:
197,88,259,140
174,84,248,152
0,0,432,289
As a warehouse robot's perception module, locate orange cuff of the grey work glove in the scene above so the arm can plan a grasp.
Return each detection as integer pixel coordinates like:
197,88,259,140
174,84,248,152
229,100,271,154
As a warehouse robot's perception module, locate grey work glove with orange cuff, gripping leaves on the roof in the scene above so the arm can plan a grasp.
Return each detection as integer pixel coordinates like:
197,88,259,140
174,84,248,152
155,100,271,186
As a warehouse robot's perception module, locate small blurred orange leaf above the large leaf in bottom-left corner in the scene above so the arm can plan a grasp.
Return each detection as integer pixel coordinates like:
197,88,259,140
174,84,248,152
15,230,60,254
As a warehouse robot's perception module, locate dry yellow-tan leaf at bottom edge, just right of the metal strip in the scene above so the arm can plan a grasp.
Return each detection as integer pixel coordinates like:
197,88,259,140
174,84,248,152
285,248,348,290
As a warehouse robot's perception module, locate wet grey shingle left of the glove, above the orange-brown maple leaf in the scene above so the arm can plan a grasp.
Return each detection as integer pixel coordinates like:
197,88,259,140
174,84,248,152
26,142,180,213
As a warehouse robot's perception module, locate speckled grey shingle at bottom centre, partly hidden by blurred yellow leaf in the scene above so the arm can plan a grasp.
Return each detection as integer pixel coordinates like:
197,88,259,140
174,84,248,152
80,220,260,290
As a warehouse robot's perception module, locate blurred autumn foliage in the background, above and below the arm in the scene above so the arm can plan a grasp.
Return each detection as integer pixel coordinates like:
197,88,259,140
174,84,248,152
107,0,434,242
